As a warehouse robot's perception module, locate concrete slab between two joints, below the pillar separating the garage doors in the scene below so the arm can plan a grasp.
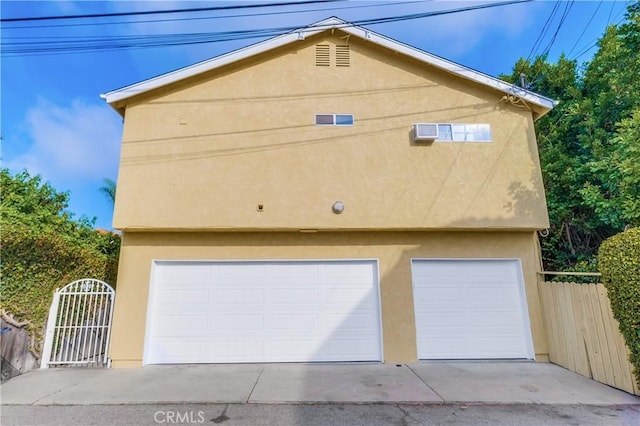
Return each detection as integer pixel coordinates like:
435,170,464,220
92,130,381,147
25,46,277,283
249,364,443,403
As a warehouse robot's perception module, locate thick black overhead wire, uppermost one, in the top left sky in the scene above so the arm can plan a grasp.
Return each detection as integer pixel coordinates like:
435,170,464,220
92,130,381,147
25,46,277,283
0,0,344,22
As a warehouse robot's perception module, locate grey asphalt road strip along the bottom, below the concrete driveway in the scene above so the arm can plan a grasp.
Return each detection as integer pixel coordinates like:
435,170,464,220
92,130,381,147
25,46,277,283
0,404,640,426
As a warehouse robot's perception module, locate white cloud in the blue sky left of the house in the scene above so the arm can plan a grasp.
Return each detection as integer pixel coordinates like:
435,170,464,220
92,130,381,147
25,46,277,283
6,98,122,183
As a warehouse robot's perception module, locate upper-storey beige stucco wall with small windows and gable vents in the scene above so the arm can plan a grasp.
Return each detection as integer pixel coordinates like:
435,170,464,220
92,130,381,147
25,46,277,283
114,31,548,231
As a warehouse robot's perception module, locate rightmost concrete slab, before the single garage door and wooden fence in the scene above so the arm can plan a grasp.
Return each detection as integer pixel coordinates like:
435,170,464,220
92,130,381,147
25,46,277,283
408,361,640,405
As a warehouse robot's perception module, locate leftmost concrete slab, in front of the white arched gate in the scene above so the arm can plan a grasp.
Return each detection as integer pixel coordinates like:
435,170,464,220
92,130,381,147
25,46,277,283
0,368,99,405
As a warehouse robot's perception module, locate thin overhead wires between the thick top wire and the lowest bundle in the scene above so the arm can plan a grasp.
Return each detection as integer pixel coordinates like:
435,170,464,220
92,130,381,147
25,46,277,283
5,0,424,30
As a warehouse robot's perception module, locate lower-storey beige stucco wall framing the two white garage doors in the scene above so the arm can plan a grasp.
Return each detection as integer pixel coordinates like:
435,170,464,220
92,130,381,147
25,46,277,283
110,232,548,368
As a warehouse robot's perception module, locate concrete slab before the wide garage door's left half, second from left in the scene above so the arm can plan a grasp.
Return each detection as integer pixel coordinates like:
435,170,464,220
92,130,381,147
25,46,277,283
36,364,262,405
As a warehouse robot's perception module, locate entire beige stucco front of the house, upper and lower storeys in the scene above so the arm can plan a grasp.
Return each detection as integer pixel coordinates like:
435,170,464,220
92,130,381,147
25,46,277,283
110,30,549,367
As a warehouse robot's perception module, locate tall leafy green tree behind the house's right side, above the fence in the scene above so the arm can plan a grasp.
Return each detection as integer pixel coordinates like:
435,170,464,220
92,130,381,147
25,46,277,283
502,2,640,270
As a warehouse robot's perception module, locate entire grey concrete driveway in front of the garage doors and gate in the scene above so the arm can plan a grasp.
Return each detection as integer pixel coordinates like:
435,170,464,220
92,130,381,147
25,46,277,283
0,361,640,406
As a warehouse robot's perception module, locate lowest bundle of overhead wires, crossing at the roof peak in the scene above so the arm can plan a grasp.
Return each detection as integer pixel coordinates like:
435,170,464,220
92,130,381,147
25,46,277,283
3,0,532,56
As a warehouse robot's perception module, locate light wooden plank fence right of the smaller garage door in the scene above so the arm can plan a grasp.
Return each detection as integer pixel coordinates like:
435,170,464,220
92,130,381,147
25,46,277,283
538,280,640,395
